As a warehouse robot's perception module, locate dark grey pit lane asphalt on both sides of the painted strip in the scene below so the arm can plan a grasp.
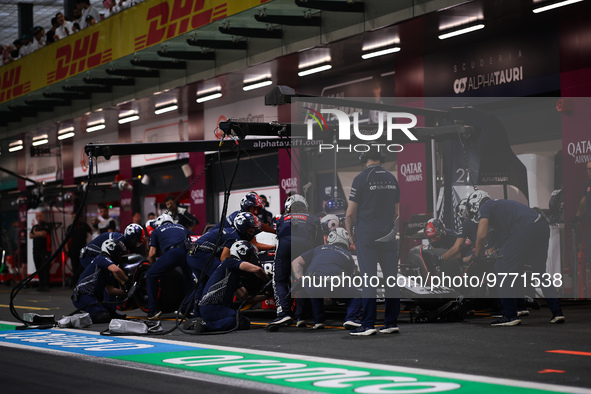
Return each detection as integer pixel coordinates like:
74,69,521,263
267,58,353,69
0,285,591,393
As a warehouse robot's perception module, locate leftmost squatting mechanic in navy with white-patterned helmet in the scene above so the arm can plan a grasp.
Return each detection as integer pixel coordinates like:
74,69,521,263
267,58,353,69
72,239,128,324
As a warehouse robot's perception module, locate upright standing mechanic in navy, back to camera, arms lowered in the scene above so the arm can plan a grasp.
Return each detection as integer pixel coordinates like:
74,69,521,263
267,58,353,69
345,151,400,336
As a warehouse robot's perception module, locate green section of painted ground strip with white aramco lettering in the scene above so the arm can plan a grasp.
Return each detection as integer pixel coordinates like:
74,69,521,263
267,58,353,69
113,349,568,394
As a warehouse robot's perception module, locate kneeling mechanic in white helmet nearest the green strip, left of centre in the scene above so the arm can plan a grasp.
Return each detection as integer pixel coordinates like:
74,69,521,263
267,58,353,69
194,240,269,332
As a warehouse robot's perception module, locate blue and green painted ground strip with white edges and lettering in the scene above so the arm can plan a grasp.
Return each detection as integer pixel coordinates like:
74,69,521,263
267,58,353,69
0,322,591,394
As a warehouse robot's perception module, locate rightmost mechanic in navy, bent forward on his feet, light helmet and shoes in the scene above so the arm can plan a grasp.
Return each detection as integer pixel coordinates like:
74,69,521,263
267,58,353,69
468,190,565,326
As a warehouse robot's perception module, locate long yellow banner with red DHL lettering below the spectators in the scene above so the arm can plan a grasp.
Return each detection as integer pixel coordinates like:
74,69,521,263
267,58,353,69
0,0,271,103
